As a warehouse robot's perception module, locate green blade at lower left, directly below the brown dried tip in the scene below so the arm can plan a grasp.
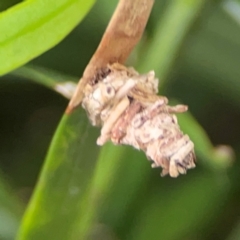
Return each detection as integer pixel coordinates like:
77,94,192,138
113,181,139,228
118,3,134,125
18,111,98,240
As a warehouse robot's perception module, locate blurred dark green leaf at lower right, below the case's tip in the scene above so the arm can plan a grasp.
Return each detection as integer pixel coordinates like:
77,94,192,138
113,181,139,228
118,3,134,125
126,172,229,240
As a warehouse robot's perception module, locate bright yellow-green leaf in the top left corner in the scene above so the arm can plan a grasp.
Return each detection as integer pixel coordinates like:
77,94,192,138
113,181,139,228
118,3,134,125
0,0,94,75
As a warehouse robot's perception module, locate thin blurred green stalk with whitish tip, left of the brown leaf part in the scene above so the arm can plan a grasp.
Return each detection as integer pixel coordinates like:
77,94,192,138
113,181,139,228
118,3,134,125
11,66,77,99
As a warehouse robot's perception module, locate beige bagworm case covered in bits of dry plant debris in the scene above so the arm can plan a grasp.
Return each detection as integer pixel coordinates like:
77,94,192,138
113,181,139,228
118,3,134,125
82,63,195,177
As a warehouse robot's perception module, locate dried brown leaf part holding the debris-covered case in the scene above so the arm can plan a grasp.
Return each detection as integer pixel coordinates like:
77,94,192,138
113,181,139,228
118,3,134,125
66,0,154,113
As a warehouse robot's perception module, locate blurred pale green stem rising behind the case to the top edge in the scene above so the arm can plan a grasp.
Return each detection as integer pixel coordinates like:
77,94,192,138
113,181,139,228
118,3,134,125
137,0,206,88
